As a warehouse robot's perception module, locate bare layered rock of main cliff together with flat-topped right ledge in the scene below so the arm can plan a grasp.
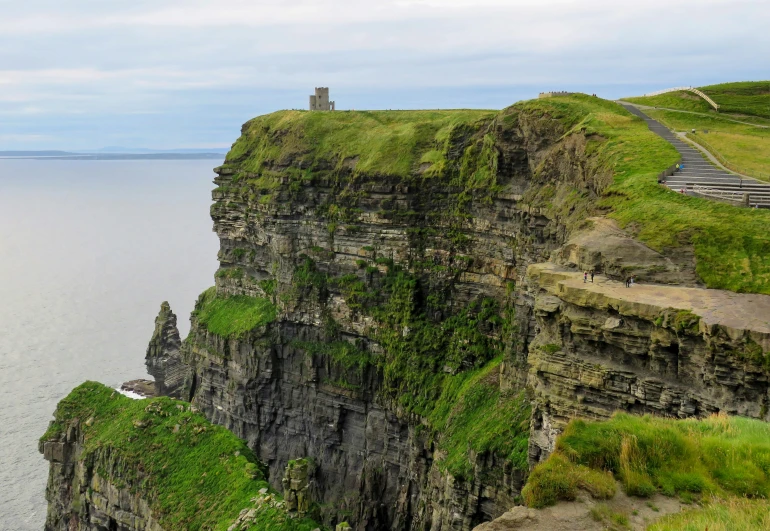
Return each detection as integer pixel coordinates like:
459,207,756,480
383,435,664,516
142,107,770,531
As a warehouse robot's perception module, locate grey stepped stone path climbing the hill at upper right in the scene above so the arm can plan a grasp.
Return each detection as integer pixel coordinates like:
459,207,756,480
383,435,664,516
619,102,770,208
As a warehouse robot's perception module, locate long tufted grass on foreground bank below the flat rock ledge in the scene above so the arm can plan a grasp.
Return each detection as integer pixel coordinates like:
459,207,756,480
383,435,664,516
524,413,770,506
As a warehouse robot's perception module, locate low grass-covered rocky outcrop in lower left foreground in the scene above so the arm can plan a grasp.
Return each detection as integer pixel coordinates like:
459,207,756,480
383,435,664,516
40,382,318,531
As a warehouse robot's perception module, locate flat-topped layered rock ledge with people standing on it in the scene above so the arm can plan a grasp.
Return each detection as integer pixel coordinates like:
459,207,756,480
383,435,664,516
527,264,770,463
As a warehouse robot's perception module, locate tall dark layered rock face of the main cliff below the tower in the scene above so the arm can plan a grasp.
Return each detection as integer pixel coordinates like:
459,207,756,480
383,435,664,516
148,106,596,530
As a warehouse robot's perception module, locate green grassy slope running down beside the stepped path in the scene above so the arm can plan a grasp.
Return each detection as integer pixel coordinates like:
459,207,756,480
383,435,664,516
521,96,770,294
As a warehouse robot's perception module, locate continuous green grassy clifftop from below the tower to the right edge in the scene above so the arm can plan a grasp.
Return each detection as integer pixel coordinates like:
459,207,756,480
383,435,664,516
225,95,770,294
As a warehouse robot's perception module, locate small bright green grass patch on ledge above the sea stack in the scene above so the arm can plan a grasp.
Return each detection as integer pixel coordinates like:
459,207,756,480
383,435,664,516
194,287,277,338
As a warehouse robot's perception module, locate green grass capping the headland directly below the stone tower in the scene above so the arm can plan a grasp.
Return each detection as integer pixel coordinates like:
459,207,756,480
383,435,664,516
225,110,496,177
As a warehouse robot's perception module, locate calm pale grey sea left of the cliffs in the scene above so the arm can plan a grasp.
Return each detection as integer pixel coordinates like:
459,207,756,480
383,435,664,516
0,160,218,531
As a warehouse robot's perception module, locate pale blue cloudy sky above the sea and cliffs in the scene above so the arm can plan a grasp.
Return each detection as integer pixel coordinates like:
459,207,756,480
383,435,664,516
0,0,770,151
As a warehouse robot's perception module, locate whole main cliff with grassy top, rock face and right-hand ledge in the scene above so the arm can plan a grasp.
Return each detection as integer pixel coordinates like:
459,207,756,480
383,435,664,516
127,96,770,531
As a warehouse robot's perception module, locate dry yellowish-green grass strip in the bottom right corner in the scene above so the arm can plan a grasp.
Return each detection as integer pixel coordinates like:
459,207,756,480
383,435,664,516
647,498,770,531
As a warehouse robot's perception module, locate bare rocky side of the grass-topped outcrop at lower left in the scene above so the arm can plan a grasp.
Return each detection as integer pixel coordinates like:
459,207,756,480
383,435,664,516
40,419,163,531
